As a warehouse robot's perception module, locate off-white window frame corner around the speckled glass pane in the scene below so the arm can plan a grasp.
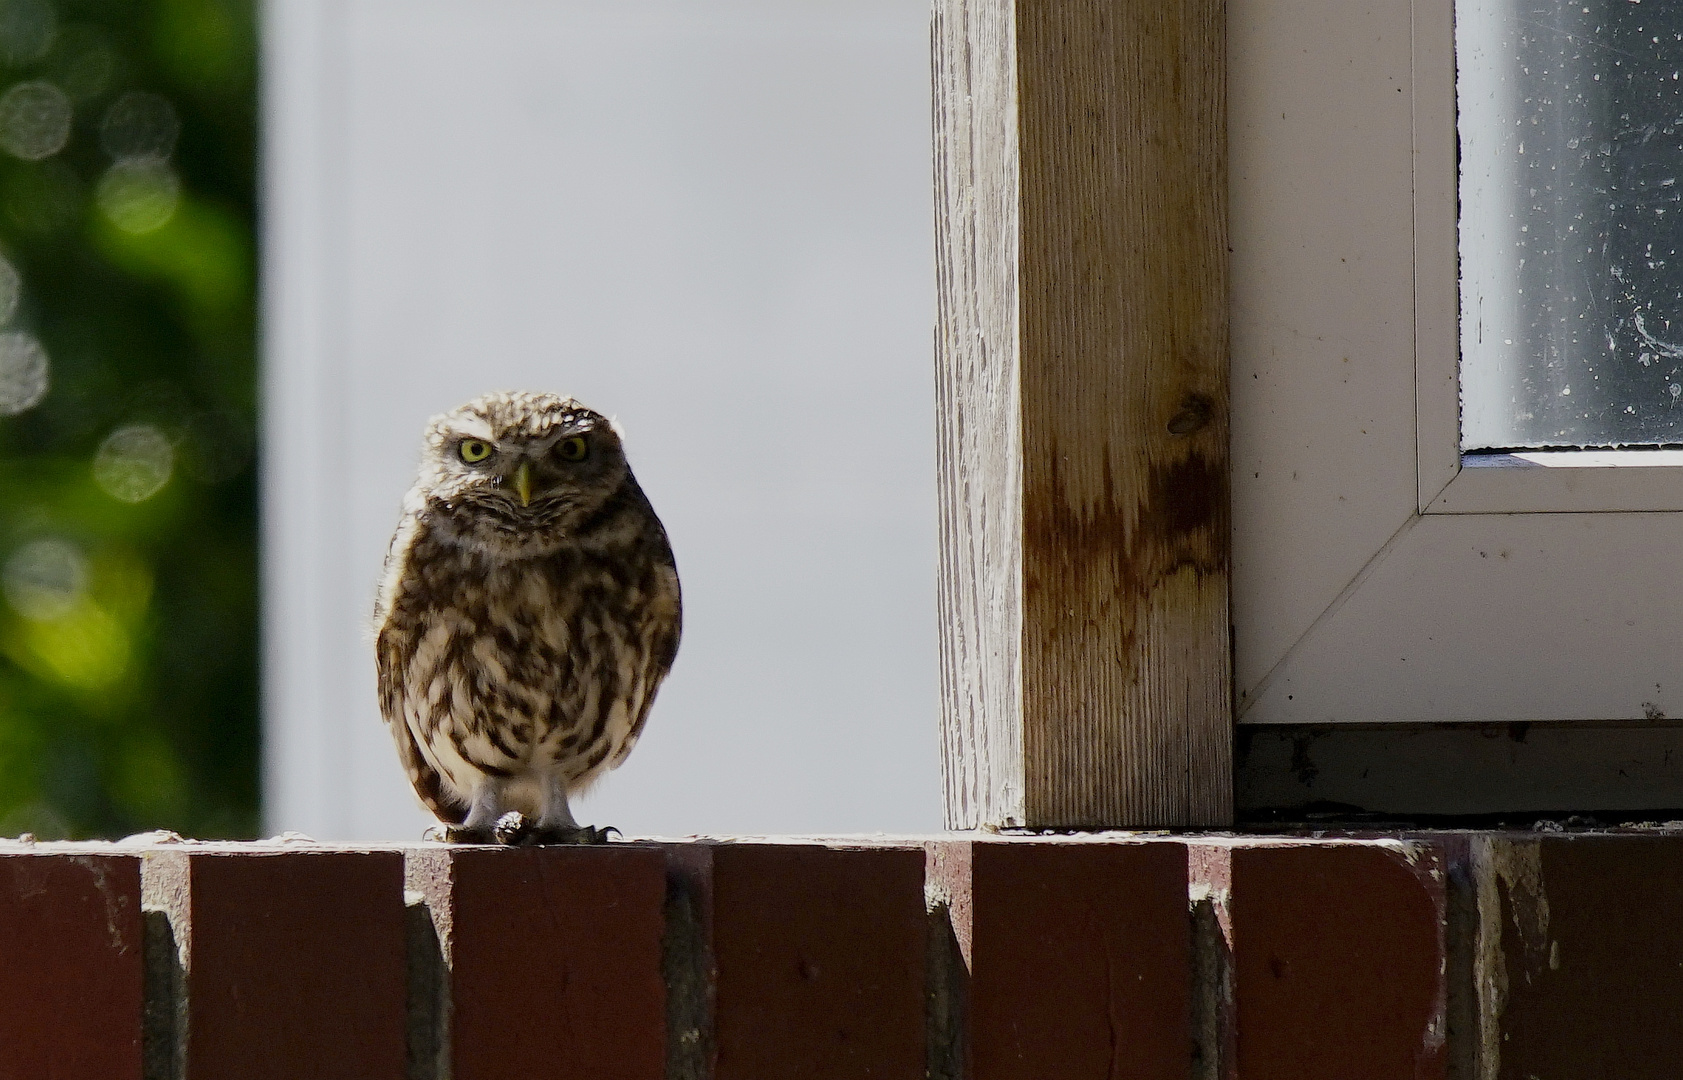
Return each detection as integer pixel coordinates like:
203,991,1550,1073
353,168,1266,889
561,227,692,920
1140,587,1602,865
1229,0,1683,725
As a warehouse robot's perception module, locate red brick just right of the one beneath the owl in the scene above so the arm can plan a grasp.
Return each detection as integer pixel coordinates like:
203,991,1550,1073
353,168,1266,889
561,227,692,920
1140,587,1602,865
712,844,927,1080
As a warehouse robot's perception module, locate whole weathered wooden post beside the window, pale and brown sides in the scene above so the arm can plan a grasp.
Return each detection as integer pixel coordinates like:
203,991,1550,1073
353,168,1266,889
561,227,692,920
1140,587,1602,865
934,0,1232,828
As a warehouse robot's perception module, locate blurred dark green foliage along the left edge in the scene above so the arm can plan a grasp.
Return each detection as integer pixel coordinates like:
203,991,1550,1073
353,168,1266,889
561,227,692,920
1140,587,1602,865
0,0,257,839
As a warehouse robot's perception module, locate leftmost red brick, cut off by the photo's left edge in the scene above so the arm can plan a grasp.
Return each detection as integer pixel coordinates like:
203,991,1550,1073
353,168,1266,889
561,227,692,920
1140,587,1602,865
0,853,145,1080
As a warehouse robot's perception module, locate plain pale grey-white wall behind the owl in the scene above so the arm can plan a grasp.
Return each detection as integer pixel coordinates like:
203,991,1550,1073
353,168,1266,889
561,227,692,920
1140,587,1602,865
263,0,941,839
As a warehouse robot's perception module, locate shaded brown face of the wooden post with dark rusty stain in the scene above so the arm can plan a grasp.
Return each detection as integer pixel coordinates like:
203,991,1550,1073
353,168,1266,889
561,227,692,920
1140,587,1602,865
1017,0,1230,826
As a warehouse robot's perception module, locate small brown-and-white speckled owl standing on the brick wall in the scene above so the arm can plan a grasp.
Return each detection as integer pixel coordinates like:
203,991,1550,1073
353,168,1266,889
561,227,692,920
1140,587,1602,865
374,394,680,843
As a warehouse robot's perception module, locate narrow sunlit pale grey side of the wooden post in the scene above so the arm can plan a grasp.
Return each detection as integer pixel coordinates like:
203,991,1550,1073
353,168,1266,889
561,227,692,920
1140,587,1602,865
934,0,1025,828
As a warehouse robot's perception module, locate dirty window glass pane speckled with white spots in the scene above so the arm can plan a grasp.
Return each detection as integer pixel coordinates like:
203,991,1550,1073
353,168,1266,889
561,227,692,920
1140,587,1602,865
1456,0,1683,451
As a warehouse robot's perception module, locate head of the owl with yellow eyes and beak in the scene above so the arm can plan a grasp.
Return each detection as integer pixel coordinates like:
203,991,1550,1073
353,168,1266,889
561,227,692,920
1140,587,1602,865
411,392,634,559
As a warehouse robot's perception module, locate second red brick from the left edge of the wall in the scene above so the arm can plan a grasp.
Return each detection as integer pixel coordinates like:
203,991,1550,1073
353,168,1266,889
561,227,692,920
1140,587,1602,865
145,844,406,1080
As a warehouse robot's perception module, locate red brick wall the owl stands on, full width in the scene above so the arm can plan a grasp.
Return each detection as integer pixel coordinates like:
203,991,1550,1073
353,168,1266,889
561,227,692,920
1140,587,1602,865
0,829,1683,1080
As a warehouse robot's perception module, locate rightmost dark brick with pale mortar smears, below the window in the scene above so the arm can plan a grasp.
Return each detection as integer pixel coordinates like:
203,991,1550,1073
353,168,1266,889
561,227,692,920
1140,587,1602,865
1478,836,1683,1080
